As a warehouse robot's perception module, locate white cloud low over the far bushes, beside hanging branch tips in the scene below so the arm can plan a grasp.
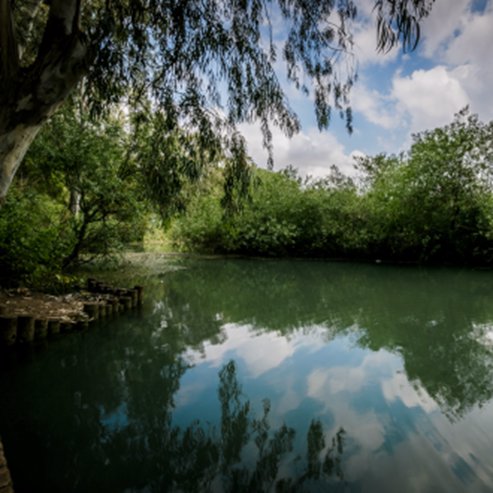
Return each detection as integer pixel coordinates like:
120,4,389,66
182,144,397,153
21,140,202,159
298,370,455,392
240,124,361,177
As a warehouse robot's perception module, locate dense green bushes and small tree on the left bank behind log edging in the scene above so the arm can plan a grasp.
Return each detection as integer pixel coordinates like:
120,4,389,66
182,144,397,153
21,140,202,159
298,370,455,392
0,106,151,287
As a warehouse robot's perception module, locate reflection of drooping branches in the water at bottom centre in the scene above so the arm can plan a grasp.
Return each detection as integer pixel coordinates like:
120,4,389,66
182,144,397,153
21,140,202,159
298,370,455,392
123,361,345,493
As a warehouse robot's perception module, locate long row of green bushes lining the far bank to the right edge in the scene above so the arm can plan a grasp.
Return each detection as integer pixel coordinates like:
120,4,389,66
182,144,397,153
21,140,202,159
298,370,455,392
171,110,493,264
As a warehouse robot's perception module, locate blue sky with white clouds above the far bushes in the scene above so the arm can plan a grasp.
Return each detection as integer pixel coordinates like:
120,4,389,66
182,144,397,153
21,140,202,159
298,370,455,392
241,0,493,177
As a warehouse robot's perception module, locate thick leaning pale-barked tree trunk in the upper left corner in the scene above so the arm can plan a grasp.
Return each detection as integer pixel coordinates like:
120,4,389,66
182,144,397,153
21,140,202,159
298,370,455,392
0,0,88,206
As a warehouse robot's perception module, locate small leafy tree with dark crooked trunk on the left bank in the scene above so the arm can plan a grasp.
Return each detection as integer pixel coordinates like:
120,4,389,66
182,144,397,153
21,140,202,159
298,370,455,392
19,102,147,268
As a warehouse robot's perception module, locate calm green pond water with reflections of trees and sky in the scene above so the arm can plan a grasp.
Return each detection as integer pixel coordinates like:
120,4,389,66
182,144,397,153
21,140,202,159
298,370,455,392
0,259,493,493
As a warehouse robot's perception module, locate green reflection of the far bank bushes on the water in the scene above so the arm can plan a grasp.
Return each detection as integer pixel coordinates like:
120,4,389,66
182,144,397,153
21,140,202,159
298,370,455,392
159,260,493,421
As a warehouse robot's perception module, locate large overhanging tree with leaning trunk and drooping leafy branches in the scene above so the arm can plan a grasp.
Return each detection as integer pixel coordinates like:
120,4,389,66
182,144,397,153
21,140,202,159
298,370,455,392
0,0,433,203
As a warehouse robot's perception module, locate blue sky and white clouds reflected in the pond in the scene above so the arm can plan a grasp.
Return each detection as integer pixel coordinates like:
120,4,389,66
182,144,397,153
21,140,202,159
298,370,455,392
172,310,493,492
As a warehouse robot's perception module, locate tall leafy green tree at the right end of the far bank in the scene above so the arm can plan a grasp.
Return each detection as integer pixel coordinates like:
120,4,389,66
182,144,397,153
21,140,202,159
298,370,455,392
359,108,493,263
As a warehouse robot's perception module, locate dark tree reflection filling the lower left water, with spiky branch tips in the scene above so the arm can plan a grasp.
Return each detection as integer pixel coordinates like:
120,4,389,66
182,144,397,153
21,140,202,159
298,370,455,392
0,328,345,493
